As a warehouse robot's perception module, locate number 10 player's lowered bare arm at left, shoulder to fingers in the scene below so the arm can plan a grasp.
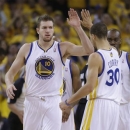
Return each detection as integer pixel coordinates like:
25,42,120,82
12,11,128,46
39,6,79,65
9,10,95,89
5,44,30,99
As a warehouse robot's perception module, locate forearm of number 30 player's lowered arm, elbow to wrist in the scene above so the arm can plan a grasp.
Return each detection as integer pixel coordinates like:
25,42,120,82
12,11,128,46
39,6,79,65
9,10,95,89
67,86,93,104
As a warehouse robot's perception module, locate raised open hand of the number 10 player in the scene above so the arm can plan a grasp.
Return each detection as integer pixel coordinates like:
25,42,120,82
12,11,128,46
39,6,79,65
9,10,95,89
67,9,81,27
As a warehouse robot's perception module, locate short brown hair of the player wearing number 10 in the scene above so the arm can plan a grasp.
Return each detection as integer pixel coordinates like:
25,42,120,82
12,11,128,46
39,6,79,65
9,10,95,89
36,14,54,28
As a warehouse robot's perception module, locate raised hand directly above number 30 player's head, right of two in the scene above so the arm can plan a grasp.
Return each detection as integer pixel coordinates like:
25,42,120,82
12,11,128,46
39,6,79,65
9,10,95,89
81,9,93,29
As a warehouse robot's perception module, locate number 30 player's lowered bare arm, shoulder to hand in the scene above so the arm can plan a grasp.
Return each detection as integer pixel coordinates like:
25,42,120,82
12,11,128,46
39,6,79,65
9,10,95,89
60,53,102,110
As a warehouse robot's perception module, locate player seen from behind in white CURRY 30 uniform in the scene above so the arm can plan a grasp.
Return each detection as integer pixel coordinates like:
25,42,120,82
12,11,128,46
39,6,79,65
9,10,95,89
60,23,121,130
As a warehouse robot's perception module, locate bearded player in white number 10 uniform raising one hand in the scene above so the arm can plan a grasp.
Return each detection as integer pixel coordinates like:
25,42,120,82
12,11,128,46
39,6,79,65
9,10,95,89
5,9,94,130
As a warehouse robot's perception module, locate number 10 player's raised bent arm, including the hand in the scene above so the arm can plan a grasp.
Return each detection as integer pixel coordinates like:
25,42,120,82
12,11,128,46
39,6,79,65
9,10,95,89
60,9,94,60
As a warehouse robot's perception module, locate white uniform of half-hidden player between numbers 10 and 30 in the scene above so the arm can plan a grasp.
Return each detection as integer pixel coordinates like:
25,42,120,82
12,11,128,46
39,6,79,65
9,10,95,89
61,59,75,130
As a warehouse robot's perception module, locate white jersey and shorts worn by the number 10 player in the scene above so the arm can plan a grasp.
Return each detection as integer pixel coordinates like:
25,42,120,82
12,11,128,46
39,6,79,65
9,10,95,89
24,41,63,130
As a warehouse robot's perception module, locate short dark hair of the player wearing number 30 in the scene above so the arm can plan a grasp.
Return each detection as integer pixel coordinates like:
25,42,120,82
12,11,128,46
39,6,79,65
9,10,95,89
90,22,107,39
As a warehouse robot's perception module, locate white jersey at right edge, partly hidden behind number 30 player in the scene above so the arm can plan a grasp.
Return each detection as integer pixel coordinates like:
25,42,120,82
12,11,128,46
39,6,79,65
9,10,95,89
120,51,130,103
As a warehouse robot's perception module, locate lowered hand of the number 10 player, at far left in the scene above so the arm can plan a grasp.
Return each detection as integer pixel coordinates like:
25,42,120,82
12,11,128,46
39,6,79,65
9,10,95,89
6,84,17,99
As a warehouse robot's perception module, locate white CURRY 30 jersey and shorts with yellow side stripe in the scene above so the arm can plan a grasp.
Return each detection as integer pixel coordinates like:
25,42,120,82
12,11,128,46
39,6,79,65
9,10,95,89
80,48,121,130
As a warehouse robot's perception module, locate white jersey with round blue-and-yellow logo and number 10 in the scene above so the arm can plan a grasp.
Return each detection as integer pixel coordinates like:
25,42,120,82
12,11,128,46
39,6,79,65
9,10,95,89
25,41,63,96
